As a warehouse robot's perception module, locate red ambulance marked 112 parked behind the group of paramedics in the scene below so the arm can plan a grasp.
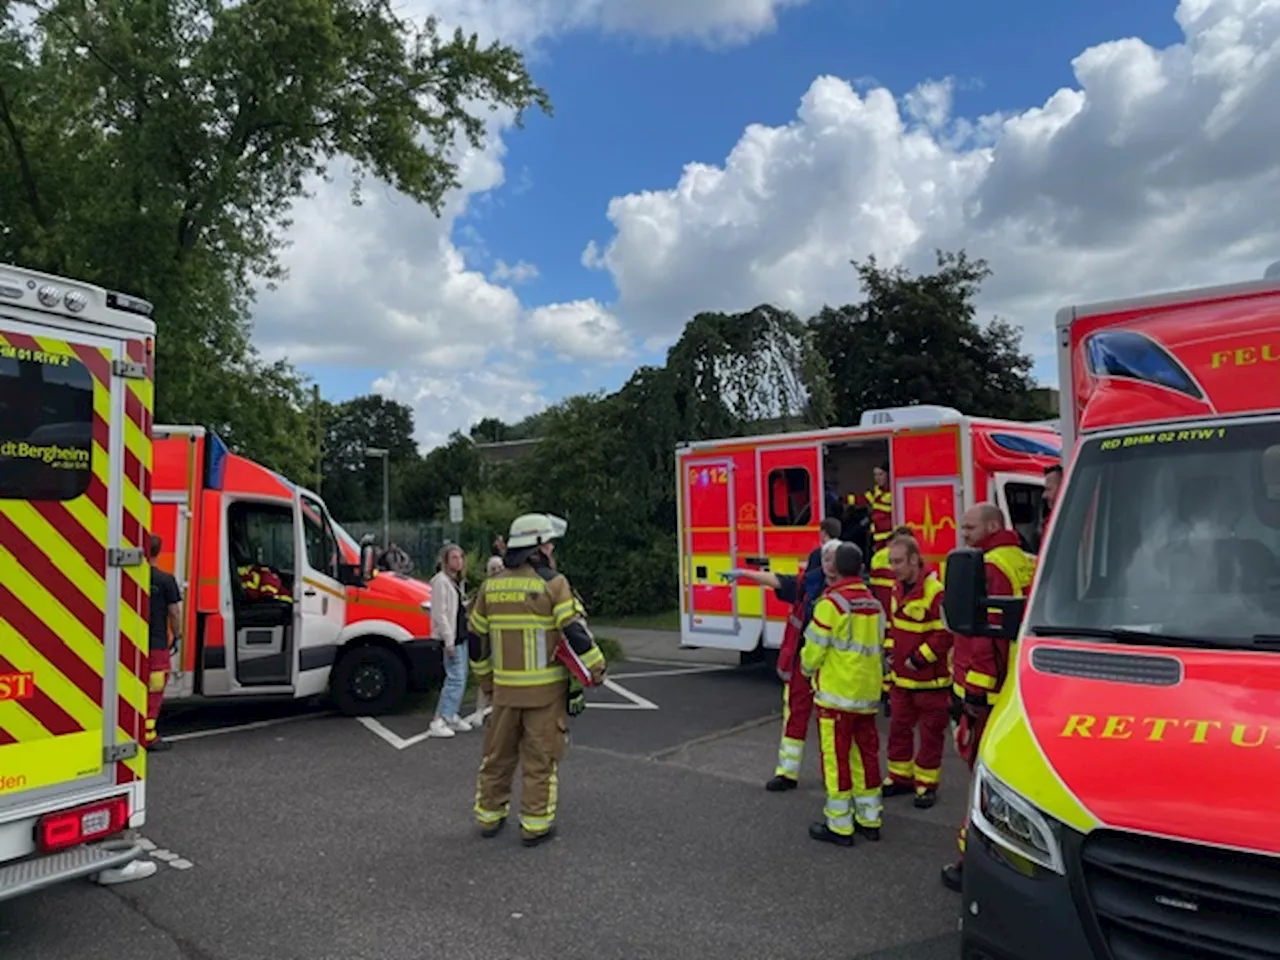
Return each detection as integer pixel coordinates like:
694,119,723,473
676,406,1060,660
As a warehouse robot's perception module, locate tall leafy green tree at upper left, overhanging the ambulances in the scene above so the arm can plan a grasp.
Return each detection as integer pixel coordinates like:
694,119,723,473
0,0,550,472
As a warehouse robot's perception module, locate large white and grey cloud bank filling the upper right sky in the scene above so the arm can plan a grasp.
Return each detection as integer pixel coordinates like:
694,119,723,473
582,0,1280,381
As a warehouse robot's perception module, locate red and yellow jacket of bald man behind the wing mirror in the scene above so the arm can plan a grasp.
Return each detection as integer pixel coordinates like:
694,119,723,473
951,530,1036,707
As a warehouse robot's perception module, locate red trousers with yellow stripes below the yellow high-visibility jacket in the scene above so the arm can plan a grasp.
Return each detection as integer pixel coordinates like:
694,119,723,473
818,707,883,836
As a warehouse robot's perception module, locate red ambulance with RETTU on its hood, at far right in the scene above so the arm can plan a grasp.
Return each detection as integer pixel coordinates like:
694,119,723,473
947,271,1280,960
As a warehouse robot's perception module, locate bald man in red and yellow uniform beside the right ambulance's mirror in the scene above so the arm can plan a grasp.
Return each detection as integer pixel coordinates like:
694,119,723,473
942,503,1036,891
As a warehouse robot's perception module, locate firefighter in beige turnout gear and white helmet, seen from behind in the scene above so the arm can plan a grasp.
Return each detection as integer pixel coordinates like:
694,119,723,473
467,513,604,846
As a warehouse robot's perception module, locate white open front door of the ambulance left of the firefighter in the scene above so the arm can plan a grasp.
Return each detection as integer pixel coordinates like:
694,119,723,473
294,493,347,696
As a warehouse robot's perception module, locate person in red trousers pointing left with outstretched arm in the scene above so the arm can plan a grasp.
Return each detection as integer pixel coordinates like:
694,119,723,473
727,517,840,792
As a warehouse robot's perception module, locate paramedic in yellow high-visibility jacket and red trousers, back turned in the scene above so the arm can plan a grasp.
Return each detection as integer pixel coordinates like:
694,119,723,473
800,540,884,846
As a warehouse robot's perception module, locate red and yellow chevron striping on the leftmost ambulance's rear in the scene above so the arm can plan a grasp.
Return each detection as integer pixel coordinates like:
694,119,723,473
0,333,151,782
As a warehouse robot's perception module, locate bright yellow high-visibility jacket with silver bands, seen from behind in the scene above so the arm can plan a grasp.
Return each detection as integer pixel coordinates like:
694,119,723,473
800,580,884,713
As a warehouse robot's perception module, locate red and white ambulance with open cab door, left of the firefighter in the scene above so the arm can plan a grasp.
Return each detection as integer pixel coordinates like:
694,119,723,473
152,425,443,716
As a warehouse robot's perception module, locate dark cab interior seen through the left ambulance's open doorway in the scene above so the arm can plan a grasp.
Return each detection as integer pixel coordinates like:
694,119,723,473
227,500,297,686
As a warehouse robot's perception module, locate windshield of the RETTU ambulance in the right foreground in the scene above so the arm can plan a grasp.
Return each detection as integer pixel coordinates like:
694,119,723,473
1027,420,1280,646
